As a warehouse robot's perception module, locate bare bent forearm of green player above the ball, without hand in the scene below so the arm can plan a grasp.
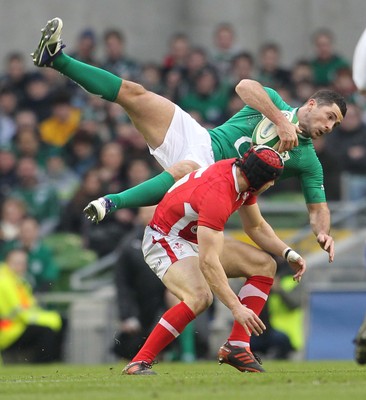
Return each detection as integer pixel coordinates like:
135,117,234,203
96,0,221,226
236,79,287,125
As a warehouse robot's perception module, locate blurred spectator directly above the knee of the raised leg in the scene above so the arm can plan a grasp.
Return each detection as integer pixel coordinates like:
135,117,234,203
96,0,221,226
102,29,140,79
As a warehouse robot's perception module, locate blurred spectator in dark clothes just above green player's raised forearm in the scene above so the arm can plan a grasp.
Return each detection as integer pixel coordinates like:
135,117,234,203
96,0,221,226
257,42,291,88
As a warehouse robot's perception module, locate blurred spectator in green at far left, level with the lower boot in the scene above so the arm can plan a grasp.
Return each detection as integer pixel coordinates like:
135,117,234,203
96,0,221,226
10,157,60,236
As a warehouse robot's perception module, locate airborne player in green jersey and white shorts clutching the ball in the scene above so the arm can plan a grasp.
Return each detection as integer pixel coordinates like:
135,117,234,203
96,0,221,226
32,18,346,262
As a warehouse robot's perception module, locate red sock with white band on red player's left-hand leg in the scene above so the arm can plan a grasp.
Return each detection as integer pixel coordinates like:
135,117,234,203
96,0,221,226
132,301,196,363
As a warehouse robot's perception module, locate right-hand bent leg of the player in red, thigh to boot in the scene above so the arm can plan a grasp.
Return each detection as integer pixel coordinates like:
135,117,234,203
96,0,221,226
218,238,276,372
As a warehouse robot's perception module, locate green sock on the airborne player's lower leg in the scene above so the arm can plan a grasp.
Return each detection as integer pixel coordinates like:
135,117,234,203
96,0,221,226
105,171,175,211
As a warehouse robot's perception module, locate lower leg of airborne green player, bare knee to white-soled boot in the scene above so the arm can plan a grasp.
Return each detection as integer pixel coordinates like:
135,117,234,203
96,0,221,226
84,160,199,223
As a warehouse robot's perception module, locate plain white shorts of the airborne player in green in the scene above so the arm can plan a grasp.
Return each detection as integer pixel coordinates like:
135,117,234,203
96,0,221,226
149,105,215,169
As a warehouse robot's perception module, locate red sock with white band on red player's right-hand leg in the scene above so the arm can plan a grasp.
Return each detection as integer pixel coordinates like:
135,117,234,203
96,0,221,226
228,276,273,347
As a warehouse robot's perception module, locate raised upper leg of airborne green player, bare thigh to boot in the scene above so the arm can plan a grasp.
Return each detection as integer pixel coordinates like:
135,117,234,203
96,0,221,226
32,18,175,149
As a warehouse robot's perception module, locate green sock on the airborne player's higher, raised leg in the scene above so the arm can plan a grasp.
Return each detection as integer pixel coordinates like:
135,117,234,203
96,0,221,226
52,53,122,102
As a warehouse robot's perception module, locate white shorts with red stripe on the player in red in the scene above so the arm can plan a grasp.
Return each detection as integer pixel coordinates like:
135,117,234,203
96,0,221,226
142,226,198,279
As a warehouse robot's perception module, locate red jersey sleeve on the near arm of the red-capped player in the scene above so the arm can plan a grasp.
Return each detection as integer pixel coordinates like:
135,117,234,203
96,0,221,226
198,182,233,231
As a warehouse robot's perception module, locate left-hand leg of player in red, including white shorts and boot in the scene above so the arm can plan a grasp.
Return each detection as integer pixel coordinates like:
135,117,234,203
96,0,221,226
123,231,212,375
